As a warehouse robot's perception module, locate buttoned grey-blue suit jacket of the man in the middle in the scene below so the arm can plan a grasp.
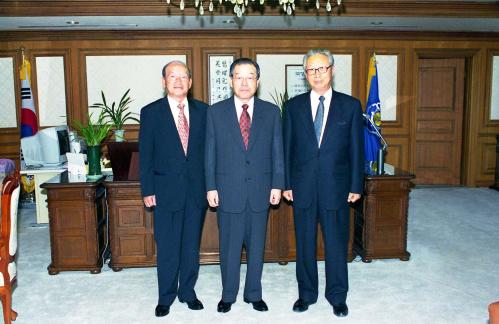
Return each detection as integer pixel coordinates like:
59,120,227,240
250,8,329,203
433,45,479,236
205,97,284,213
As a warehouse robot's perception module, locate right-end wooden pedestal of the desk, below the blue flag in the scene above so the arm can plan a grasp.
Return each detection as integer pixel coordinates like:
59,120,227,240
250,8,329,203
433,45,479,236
354,169,414,262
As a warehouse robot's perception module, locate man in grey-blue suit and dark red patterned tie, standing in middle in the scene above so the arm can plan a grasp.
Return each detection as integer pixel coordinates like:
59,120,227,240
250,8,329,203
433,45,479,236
205,58,284,313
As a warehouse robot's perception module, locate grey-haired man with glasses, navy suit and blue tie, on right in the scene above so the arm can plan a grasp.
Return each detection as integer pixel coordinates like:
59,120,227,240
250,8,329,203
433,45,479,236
283,49,364,316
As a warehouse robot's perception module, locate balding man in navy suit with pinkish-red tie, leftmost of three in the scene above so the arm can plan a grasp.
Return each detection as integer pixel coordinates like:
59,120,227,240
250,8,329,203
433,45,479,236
139,61,208,317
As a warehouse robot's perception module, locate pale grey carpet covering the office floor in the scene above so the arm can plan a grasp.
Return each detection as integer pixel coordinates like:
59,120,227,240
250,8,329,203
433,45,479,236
6,188,499,324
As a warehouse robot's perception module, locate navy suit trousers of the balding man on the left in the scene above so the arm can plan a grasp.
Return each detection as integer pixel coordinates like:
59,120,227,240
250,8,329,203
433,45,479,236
154,203,206,306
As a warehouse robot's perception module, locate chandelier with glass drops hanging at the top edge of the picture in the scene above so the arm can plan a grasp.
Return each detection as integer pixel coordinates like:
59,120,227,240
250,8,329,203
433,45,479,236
166,0,342,18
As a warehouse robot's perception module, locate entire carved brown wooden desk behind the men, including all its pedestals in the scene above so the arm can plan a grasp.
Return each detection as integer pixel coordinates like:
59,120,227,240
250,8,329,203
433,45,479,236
42,172,413,274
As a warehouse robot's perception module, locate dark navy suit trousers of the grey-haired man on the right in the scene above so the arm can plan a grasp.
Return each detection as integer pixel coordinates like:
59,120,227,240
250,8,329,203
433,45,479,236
293,199,350,305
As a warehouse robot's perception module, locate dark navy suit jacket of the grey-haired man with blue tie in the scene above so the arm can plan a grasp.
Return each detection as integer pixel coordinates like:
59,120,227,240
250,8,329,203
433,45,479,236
284,91,364,210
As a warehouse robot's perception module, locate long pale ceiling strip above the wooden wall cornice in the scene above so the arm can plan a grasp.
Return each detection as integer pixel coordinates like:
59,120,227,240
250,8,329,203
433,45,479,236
0,14,499,32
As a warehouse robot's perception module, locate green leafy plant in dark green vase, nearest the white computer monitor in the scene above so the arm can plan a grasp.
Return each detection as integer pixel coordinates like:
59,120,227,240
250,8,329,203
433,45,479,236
73,111,112,177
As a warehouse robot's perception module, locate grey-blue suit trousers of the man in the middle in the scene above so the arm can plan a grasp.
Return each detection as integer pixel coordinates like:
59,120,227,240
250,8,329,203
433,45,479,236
217,204,268,303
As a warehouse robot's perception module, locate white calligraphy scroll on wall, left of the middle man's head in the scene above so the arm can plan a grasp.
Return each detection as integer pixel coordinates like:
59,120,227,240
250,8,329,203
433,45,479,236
208,54,235,105
